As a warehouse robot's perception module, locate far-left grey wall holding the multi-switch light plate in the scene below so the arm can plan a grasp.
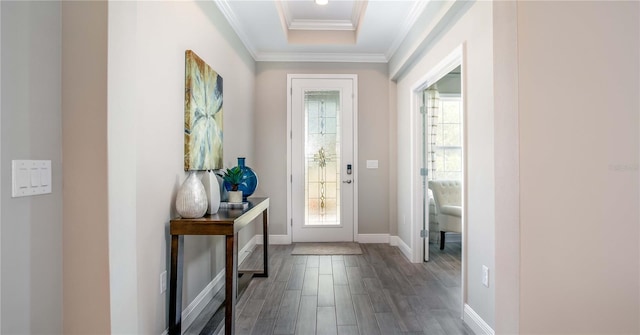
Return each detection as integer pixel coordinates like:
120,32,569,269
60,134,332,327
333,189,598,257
0,1,63,334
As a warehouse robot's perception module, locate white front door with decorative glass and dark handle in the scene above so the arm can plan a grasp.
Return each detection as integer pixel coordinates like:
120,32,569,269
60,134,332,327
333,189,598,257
288,75,357,242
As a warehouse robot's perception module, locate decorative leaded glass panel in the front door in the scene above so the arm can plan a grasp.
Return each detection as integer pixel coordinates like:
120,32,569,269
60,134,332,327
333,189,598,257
304,91,341,226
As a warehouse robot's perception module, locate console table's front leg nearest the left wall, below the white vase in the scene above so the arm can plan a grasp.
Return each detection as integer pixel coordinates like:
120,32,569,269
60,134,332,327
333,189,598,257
169,235,184,335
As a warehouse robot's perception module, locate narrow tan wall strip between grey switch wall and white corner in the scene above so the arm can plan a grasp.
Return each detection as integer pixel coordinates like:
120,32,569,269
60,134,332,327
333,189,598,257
62,2,110,334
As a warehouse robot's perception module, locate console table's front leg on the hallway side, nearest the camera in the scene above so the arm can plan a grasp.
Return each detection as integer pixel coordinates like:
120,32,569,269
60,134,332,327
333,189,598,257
224,234,238,335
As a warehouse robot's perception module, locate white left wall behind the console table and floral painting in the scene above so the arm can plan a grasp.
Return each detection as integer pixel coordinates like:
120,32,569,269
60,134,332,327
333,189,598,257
109,1,255,334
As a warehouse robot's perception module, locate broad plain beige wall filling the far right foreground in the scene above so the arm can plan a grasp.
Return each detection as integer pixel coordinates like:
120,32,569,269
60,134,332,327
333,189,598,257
518,1,640,334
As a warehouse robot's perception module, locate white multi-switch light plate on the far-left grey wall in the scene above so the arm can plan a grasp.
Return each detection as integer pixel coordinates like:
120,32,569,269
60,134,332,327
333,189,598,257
11,160,51,198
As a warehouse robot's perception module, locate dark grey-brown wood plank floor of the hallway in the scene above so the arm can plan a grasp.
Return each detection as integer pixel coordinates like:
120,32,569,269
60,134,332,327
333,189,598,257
185,242,464,335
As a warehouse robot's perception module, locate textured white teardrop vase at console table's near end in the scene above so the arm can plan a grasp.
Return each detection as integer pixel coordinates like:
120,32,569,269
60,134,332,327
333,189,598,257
176,171,208,219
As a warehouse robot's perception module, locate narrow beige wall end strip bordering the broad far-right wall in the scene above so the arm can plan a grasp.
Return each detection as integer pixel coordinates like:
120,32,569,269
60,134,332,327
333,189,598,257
492,1,520,334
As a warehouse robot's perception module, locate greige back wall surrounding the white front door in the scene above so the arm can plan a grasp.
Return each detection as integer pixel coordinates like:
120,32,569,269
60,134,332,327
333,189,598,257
254,62,393,239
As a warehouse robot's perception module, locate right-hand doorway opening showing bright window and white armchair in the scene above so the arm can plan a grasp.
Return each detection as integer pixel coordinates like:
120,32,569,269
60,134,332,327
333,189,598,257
421,65,464,261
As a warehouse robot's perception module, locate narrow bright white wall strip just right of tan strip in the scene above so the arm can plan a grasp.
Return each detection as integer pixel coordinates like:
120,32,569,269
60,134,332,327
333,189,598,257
107,2,139,334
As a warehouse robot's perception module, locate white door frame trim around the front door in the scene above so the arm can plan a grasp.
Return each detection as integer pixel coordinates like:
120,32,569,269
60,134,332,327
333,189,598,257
285,73,358,244
